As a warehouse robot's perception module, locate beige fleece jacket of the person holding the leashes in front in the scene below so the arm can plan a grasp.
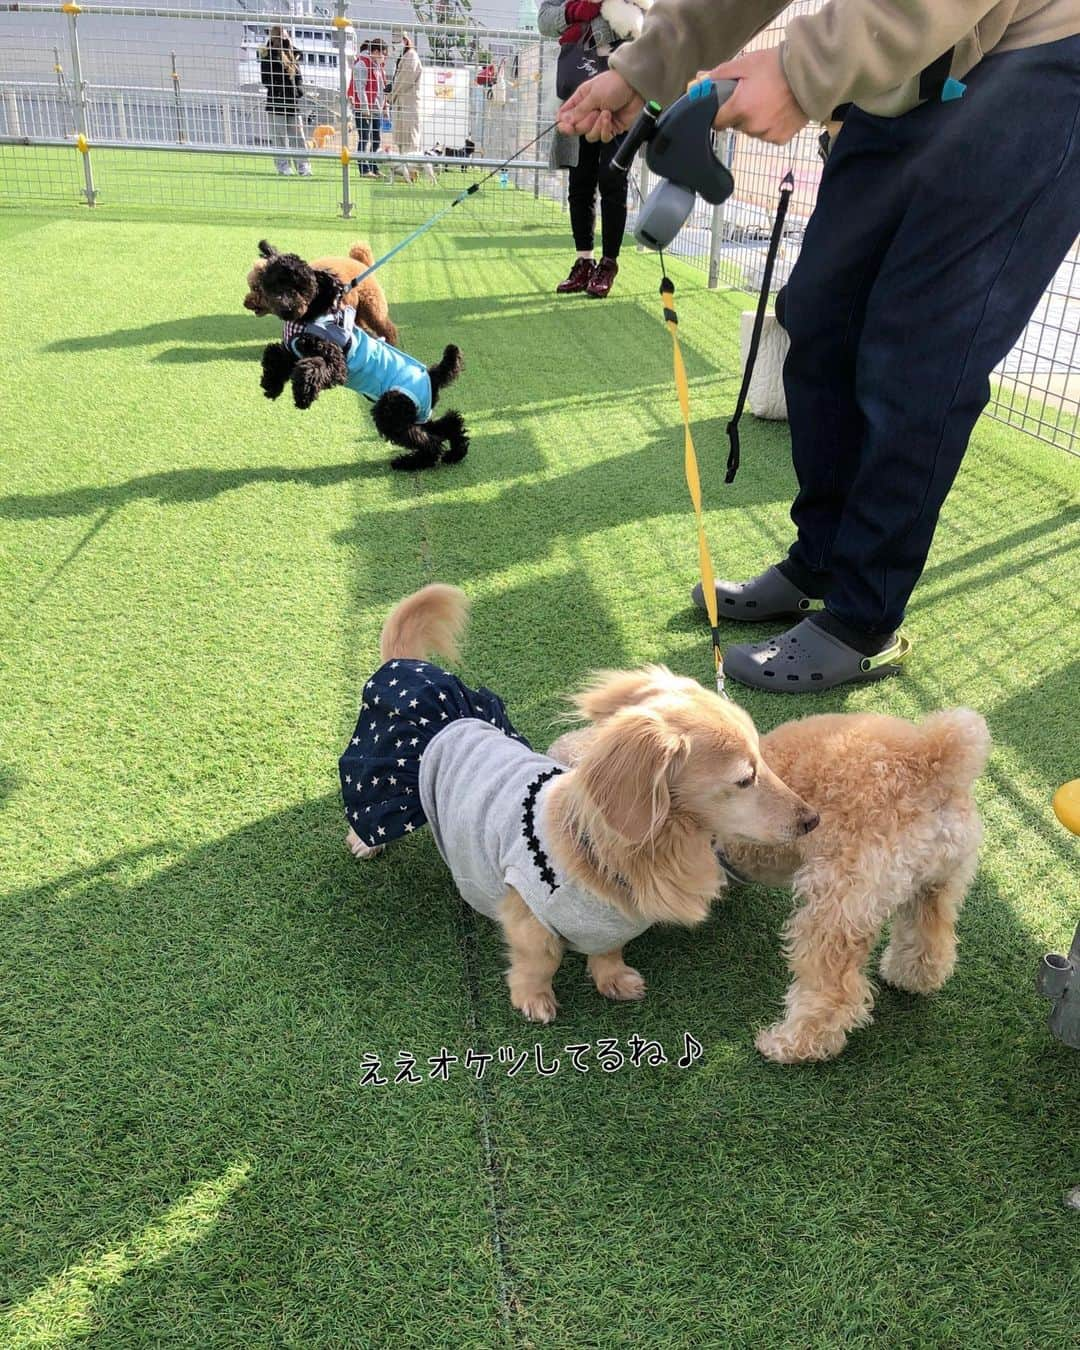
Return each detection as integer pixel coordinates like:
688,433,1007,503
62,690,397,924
610,0,1080,122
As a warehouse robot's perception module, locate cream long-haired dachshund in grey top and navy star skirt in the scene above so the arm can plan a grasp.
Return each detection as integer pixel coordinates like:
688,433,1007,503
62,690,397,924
340,585,818,1022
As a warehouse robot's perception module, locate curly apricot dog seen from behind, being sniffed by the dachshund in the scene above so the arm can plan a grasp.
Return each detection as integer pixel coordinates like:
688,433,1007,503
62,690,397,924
551,707,990,1062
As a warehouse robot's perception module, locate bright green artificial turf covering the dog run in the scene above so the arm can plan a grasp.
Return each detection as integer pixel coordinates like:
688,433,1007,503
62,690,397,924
0,182,1080,1350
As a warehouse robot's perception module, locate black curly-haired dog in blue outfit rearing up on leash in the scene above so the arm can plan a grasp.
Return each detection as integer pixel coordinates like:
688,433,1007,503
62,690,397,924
259,240,468,470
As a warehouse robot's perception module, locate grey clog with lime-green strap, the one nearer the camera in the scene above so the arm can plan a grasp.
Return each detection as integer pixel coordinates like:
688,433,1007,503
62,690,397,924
724,618,911,694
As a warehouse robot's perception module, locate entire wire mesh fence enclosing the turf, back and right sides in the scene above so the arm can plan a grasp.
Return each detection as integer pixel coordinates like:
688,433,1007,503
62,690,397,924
0,0,1080,454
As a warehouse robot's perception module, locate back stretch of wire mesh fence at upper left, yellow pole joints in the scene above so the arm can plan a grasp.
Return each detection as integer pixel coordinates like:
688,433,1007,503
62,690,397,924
0,0,559,225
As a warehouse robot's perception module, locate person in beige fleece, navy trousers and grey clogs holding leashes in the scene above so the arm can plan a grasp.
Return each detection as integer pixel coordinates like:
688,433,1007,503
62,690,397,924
559,0,1080,694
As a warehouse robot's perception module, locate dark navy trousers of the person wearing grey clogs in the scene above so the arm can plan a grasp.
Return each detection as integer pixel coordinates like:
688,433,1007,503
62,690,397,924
784,36,1080,633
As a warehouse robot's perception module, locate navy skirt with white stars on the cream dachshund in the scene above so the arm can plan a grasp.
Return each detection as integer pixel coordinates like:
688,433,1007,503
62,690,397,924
338,659,532,844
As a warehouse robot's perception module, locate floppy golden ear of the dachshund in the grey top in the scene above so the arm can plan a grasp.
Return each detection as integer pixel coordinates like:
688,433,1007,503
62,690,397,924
575,709,689,844
